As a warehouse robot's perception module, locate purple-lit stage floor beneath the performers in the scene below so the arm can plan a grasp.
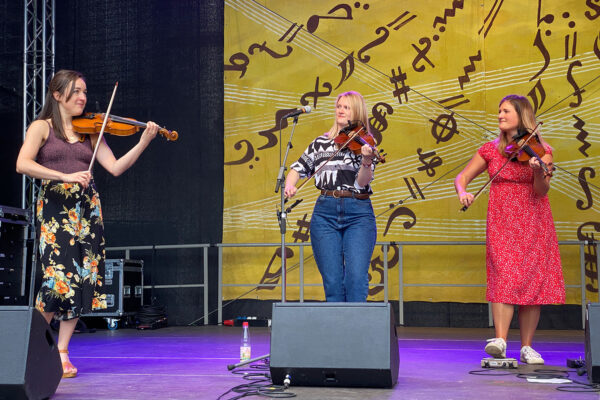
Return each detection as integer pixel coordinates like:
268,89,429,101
52,326,600,400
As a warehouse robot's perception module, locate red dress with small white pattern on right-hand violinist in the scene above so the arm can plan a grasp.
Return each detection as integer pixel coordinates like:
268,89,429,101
478,141,565,305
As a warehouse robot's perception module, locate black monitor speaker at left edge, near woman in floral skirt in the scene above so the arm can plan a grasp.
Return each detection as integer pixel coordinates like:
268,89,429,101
0,306,62,400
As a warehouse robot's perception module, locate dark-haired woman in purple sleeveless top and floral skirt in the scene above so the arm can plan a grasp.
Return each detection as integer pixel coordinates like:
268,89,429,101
17,70,158,377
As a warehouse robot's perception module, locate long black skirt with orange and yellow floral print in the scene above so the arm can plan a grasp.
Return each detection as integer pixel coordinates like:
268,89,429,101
35,180,106,320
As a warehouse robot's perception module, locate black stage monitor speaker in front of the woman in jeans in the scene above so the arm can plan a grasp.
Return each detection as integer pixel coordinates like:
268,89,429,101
270,303,399,388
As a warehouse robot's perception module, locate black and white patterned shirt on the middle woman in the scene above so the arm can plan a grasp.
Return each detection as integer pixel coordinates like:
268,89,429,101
290,135,375,194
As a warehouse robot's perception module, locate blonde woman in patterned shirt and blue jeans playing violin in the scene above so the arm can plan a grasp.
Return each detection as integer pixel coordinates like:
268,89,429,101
285,91,377,302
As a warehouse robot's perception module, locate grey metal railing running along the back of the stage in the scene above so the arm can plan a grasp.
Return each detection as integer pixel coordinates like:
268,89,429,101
106,241,600,327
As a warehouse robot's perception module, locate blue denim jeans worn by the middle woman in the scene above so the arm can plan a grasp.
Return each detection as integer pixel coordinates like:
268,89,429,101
310,195,377,302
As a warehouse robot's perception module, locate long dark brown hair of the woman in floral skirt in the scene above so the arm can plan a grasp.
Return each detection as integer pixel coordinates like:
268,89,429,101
36,69,85,141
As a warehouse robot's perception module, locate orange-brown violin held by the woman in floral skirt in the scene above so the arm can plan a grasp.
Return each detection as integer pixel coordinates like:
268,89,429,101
72,113,179,141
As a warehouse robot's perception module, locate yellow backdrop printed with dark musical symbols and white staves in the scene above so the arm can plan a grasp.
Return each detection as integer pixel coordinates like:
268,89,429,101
223,0,600,304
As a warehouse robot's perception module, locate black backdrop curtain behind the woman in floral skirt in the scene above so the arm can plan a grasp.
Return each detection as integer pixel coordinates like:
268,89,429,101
0,0,223,325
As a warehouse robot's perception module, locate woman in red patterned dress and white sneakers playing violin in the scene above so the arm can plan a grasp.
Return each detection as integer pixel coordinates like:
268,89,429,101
454,95,565,364
